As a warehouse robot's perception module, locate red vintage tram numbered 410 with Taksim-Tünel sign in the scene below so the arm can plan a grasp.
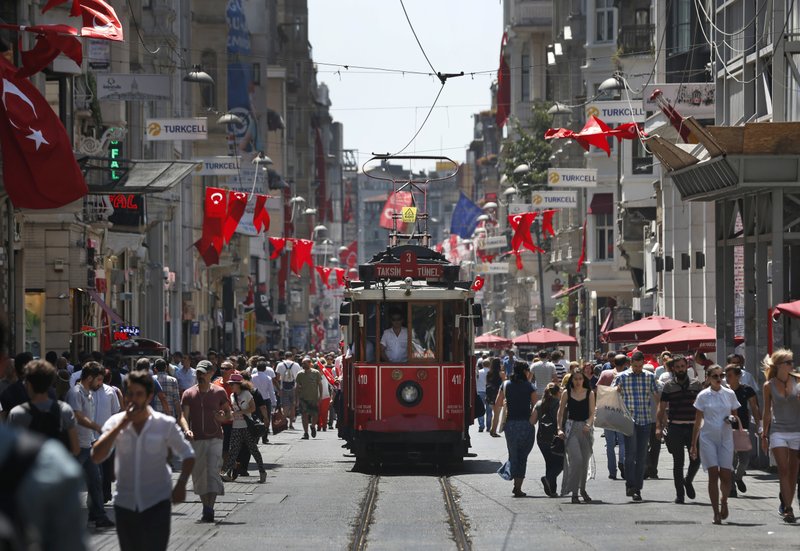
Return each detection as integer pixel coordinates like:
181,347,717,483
340,157,481,466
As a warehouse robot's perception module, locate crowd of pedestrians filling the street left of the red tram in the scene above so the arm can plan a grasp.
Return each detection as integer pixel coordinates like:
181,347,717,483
0,324,342,550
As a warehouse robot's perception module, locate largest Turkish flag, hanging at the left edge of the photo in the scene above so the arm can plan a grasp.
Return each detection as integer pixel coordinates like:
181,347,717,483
0,58,89,209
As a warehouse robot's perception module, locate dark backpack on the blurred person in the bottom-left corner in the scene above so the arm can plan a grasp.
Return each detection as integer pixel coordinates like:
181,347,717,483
0,431,44,551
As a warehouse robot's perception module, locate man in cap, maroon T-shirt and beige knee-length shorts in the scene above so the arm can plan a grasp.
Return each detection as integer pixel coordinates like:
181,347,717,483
181,360,233,522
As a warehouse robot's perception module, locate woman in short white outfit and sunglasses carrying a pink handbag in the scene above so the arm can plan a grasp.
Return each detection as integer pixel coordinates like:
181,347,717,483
689,365,741,524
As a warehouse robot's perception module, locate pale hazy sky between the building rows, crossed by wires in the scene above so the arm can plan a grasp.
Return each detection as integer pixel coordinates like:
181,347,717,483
308,0,503,172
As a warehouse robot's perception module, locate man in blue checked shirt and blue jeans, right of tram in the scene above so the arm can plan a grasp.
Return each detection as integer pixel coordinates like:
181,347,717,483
612,351,658,501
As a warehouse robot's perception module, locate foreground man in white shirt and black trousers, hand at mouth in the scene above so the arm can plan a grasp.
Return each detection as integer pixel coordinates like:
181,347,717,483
92,371,194,550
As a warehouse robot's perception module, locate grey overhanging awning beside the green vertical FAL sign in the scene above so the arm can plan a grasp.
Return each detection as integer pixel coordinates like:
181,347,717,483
78,156,199,194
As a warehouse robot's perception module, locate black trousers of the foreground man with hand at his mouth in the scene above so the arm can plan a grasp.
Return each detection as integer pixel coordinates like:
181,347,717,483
114,499,172,551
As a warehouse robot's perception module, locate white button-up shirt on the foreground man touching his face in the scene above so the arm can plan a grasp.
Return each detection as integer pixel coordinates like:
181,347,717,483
103,408,194,511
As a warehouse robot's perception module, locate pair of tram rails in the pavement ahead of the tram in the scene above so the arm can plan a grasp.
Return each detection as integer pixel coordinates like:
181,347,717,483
350,475,472,551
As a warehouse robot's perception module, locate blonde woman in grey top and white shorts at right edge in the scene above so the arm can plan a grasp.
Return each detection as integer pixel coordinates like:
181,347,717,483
761,348,800,522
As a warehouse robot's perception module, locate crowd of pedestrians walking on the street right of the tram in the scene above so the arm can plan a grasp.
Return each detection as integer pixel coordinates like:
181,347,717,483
477,349,800,524
